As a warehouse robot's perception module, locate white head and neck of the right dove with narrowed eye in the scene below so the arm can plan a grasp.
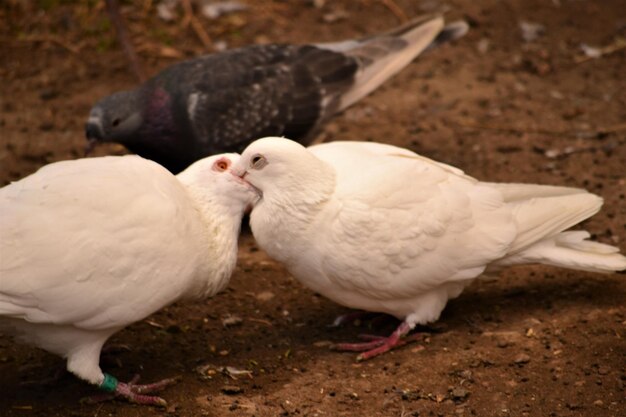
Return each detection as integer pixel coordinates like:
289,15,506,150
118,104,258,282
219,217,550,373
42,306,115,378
231,137,335,262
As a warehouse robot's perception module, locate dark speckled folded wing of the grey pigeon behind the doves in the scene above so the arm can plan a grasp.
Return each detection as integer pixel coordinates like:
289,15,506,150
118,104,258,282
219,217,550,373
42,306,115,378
162,45,358,154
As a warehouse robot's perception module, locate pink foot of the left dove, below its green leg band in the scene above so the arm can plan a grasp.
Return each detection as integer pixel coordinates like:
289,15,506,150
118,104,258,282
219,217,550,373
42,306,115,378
85,374,180,407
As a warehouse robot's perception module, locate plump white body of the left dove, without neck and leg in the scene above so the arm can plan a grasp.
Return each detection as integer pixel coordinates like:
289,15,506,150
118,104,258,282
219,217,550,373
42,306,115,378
0,156,205,329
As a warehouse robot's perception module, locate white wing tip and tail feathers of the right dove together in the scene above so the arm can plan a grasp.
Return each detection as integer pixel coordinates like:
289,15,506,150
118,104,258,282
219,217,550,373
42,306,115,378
494,188,626,272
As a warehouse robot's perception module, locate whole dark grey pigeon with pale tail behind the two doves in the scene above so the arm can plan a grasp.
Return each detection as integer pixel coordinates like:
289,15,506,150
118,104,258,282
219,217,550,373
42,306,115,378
85,15,468,172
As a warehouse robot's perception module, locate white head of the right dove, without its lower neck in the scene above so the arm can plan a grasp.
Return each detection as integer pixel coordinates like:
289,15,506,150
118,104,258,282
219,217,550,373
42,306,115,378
231,137,335,205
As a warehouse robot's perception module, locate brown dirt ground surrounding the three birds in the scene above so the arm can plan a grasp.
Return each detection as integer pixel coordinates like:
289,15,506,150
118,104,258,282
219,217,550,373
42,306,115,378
0,0,626,417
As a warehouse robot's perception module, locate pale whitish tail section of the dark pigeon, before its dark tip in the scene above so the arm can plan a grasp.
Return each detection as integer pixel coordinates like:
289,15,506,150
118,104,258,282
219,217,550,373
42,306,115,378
338,16,444,110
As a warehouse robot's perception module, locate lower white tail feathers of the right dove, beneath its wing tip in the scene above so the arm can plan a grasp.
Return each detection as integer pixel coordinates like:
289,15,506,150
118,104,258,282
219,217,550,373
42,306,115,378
503,231,626,273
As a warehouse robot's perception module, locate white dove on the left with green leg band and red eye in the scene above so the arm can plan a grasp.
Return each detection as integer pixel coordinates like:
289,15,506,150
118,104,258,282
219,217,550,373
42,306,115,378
0,154,256,405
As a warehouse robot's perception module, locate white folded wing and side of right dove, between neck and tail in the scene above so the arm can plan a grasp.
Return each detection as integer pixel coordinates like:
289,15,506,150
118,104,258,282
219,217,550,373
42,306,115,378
309,142,515,299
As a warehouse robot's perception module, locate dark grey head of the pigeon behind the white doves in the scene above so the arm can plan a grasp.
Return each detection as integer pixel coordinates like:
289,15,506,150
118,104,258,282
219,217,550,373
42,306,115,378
85,90,143,150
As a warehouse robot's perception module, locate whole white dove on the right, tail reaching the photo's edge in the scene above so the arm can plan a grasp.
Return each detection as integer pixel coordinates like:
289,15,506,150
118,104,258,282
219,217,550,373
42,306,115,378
231,138,626,360
